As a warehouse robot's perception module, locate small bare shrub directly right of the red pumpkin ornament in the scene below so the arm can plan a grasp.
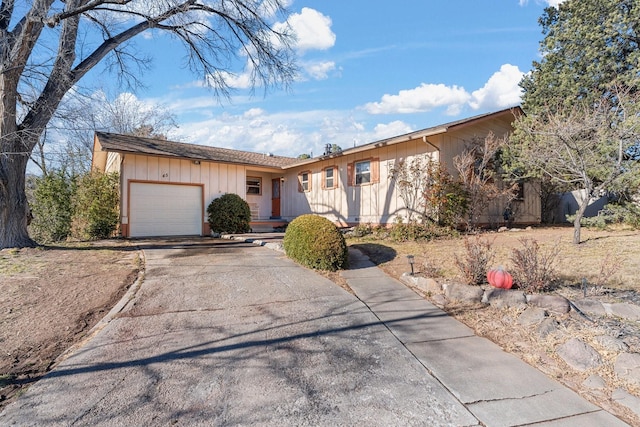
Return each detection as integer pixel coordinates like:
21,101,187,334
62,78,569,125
511,238,560,292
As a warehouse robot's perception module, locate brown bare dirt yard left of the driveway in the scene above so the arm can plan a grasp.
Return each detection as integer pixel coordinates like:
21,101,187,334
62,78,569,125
0,240,139,410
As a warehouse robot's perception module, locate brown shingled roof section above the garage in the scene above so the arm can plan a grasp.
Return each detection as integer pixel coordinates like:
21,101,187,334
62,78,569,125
95,132,297,168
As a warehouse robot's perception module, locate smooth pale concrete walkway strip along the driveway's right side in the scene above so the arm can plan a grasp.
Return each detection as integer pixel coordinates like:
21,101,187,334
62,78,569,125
228,235,627,427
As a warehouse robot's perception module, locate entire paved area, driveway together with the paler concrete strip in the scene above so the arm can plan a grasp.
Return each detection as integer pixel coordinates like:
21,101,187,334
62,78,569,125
0,236,626,426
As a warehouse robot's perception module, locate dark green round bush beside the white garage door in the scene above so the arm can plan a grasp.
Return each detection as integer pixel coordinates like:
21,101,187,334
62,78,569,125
207,193,251,233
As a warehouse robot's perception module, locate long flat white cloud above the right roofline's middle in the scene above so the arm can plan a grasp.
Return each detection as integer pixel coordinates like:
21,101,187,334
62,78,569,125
364,83,471,114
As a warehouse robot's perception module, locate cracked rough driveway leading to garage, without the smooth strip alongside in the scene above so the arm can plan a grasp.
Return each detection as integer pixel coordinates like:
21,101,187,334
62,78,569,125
0,239,479,426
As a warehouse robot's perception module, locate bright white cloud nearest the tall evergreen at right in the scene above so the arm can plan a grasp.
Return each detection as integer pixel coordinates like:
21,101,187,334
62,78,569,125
469,64,524,110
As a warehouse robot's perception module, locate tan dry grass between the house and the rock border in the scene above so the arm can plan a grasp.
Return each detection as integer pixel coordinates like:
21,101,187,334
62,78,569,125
349,227,640,290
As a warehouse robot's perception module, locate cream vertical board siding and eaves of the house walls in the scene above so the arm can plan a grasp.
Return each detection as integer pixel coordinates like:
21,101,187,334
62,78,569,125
115,110,540,231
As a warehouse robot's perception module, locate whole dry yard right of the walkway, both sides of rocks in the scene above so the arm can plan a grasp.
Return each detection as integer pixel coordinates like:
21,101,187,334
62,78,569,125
349,227,640,425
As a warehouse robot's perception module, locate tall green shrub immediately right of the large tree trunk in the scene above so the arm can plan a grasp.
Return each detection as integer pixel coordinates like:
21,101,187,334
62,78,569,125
30,171,74,243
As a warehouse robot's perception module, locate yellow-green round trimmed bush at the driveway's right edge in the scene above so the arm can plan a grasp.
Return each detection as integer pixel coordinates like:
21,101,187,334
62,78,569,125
283,215,348,271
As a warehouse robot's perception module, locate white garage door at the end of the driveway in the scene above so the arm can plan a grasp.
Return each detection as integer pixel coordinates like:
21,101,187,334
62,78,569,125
129,182,203,237
